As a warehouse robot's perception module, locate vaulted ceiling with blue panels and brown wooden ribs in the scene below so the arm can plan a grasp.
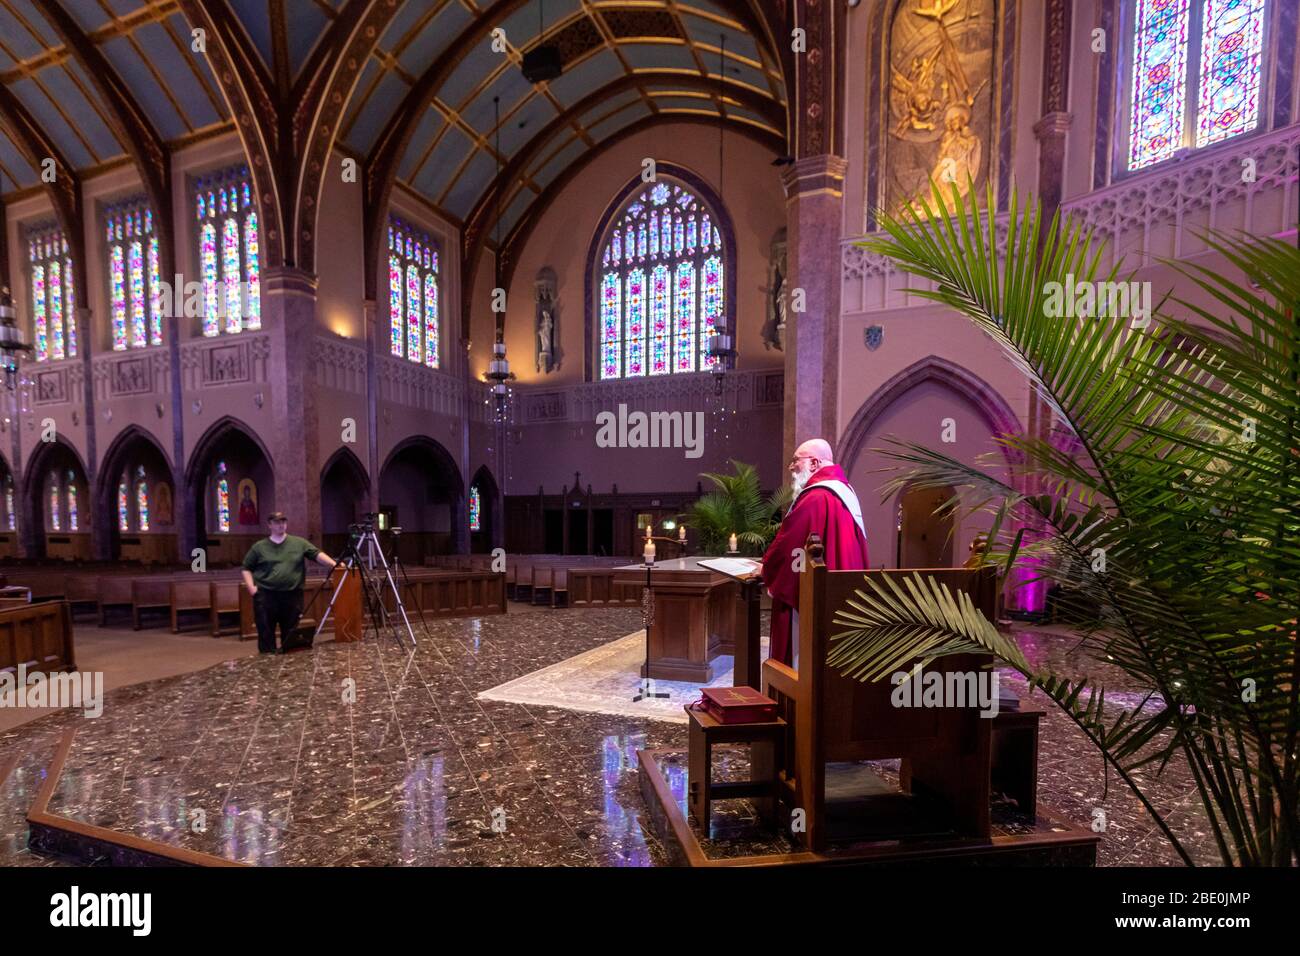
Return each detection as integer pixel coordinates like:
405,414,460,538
0,0,787,251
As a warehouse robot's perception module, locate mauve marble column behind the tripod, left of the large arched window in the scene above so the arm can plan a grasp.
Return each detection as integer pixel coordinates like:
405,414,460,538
261,267,321,542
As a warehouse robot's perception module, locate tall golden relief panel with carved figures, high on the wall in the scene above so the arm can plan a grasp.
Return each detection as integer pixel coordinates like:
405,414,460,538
885,0,995,216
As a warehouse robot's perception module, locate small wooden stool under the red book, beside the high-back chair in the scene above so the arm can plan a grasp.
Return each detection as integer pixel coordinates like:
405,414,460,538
685,706,785,835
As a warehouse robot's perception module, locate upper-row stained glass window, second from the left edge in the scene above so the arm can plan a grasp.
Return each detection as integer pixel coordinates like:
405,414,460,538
104,199,163,351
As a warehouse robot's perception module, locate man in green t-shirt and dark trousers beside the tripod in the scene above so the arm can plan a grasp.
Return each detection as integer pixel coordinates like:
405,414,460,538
243,511,335,654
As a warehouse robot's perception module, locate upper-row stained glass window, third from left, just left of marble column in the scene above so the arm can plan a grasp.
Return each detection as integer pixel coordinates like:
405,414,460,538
194,166,261,338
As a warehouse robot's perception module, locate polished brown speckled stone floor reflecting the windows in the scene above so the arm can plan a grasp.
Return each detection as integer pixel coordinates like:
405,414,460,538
0,606,1217,866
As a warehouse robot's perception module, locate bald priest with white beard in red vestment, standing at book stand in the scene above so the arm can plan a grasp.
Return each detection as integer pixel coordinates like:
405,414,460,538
763,438,868,665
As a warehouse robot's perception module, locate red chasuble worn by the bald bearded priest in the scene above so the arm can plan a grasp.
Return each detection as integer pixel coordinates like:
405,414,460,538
763,464,868,663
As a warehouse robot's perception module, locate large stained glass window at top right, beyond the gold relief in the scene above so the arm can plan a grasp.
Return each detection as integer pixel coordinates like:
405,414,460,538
1127,0,1268,169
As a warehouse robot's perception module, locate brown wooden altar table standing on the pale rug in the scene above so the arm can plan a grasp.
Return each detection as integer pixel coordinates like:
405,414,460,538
614,558,762,688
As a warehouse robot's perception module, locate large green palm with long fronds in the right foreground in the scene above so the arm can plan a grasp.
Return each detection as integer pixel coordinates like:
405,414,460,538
831,178,1300,866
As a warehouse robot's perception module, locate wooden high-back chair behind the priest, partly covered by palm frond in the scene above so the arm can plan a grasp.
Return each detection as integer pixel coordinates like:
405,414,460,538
763,535,997,852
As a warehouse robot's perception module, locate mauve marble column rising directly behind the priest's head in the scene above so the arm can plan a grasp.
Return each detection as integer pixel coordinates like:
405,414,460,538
781,155,848,462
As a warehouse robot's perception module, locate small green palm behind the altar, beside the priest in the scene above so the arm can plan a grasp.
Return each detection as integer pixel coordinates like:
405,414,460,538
683,460,790,555
